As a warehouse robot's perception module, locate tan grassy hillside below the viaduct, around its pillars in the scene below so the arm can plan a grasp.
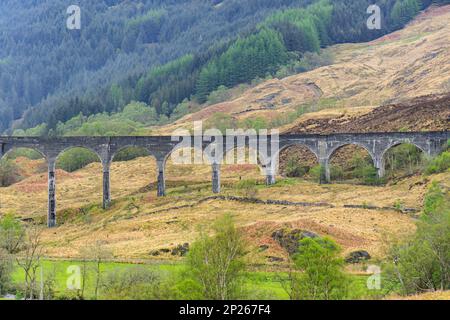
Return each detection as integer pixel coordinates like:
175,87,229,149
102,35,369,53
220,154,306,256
0,149,450,265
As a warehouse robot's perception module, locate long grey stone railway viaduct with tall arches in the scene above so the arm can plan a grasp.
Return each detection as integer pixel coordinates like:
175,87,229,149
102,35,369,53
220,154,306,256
0,131,450,227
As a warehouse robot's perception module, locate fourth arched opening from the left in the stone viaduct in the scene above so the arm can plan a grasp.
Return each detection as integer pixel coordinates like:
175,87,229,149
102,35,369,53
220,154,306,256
165,147,212,195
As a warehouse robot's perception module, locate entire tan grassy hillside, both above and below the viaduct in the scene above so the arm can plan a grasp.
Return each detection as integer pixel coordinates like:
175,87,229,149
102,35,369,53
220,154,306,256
0,6,450,264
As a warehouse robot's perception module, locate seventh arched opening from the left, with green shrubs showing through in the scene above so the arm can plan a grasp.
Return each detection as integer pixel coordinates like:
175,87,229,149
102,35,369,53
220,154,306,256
329,144,377,184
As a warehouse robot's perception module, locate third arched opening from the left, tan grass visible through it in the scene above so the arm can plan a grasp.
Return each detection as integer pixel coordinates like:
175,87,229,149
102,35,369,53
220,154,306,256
110,146,157,200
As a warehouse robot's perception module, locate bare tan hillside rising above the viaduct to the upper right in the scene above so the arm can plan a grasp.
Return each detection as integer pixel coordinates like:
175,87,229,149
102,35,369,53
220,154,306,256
156,6,450,134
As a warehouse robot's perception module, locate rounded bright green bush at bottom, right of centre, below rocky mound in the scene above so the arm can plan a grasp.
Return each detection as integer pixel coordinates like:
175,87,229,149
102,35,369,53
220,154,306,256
289,238,350,300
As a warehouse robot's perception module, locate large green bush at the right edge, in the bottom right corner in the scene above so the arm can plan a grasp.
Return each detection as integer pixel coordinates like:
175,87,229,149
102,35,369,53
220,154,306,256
386,183,450,294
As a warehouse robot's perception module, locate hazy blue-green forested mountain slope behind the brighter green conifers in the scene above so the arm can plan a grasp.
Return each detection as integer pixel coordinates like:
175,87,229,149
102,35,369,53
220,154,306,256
0,0,311,132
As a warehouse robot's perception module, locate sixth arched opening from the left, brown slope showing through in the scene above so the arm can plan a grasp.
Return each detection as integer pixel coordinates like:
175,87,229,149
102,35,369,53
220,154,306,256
278,145,320,181
